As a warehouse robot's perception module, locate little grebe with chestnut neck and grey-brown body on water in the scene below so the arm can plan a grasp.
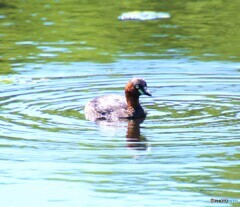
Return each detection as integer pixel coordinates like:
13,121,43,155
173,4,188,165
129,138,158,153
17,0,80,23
85,78,151,121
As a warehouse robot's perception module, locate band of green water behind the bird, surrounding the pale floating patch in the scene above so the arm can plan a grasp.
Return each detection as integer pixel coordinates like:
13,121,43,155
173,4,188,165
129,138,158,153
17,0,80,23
0,0,240,72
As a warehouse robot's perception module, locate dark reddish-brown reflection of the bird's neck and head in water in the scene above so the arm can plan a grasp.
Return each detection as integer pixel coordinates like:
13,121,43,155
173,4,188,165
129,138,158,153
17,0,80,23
126,118,148,151
